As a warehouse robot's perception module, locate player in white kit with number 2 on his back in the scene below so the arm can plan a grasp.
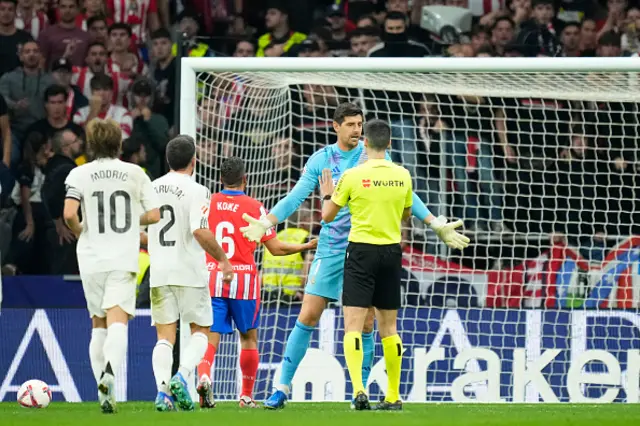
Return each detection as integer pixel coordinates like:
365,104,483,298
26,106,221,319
148,135,233,411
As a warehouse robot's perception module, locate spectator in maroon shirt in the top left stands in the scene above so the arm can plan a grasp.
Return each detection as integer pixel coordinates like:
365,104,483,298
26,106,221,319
38,0,90,69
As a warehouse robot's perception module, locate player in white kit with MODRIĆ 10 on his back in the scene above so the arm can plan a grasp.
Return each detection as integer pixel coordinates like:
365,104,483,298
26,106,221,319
64,118,160,413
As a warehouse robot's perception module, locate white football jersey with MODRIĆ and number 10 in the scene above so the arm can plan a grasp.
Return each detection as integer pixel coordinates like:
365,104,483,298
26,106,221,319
65,159,158,274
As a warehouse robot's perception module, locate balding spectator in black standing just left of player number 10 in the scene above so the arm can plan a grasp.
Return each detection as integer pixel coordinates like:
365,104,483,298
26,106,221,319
42,130,82,275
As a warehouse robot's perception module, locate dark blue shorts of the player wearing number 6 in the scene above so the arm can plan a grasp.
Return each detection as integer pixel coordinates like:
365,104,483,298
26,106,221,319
211,297,260,334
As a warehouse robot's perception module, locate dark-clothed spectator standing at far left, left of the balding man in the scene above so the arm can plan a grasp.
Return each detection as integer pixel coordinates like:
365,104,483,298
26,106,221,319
6,133,51,275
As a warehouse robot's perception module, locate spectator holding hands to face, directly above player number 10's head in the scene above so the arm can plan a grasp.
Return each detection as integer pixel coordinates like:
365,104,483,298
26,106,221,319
73,73,133,136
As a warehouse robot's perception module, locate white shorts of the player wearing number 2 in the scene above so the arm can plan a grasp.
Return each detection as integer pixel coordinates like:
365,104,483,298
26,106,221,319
151,285,213,327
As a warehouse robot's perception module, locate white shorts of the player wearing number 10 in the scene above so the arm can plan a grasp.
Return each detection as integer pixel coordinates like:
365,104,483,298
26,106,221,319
80,271,137,318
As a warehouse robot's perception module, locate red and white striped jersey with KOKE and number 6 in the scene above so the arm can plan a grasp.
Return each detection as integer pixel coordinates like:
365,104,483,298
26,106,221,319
207,190,276,300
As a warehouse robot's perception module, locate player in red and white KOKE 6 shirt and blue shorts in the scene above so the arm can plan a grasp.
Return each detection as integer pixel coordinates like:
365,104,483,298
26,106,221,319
198,157,317,408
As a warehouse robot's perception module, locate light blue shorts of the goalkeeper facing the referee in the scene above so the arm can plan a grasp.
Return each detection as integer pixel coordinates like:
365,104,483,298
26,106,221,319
304,254,344,300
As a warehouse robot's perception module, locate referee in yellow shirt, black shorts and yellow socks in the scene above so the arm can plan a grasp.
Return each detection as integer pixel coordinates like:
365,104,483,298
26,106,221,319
320,120,412,410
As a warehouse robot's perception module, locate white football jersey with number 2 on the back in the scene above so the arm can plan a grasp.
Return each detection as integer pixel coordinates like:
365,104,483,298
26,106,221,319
148,172,211,287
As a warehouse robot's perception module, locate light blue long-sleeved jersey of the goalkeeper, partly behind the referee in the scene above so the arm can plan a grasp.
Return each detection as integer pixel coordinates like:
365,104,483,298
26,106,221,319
270,142,430,258
